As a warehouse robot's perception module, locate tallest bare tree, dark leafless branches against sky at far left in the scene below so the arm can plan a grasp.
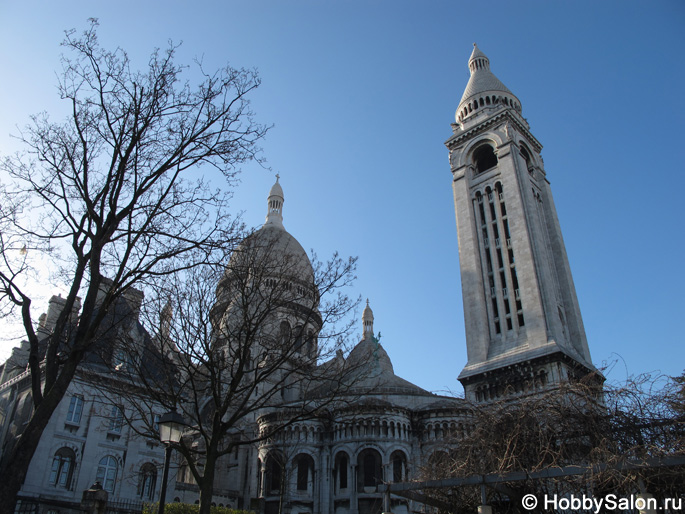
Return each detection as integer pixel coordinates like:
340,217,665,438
0,20,267,506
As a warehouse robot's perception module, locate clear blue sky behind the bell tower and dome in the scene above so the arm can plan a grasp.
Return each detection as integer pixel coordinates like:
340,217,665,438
0,0,685,392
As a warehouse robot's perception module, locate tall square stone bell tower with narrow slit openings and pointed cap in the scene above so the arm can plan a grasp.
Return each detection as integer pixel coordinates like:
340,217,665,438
445,44,602,401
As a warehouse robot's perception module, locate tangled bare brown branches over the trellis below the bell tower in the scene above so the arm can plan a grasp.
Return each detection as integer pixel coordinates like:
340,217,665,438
420,376,685,512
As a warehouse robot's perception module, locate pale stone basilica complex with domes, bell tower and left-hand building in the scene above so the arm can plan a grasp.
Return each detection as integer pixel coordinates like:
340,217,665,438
0,44,597,514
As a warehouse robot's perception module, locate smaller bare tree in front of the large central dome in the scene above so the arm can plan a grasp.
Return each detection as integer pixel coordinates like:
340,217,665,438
93,230,359,513
